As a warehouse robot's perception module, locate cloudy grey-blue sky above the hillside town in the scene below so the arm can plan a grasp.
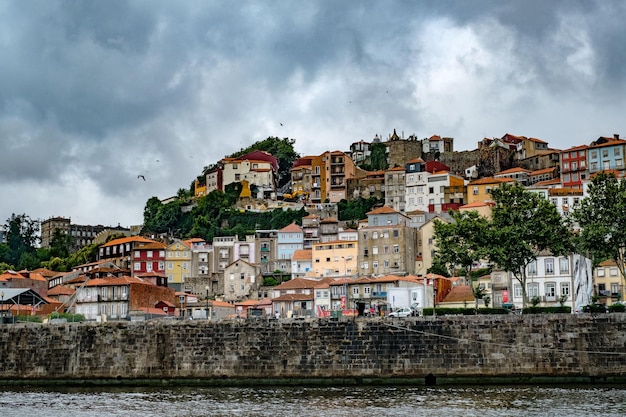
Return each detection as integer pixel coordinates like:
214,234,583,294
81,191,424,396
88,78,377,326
0,0,626,227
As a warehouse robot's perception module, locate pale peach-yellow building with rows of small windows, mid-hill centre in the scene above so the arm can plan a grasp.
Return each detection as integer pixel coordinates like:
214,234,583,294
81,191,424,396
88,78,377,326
311,240,359,277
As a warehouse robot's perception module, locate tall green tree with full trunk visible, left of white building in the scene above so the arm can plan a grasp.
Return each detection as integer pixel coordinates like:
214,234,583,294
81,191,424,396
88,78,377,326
488,183,572,307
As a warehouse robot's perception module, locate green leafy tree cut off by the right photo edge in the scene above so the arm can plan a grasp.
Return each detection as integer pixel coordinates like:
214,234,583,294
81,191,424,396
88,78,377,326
572,172,626,280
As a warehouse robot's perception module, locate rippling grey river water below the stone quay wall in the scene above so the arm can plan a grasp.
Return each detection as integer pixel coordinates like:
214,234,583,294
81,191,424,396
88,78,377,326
0,385,626,417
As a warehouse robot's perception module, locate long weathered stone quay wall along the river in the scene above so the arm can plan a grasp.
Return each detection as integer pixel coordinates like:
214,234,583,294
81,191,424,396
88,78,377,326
0,314,626,384
